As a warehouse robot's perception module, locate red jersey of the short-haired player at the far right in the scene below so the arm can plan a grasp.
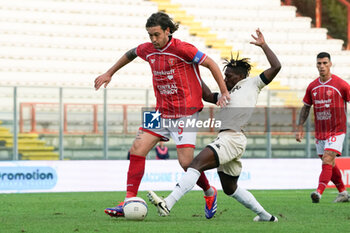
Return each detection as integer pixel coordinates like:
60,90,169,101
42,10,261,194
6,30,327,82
303,75,350,140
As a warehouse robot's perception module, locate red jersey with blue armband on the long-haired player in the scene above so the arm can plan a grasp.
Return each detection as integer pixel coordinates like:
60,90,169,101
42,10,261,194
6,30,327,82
136,38,207,118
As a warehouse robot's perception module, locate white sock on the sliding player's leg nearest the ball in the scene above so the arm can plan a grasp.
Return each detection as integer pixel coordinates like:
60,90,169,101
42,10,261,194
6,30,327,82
164,168,201,210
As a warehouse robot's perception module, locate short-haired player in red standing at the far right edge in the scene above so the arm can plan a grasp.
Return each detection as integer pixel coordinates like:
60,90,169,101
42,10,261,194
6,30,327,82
295,52,350,203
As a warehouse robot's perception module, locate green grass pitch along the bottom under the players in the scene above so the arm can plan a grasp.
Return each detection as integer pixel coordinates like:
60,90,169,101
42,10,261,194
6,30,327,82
0,189,350,233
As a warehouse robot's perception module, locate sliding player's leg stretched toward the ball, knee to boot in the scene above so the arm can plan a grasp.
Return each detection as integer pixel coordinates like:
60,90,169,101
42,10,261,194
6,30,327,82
148,147,218,216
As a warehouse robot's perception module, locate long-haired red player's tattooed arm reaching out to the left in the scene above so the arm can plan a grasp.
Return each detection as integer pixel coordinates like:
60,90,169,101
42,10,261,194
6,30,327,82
95,48,137,90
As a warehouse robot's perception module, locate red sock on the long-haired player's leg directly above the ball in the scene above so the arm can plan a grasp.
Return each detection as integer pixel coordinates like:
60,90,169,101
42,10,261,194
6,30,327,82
126,154,146,198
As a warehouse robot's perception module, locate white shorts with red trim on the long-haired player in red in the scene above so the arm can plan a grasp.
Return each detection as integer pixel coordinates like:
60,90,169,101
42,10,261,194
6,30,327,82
140,112,198,148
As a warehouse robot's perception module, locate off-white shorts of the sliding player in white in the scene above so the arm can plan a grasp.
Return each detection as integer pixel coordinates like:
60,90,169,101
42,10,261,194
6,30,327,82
208,131,247,176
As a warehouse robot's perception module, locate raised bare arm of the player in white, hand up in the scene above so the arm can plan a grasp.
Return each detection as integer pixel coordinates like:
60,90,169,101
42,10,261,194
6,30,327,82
250,28,281,82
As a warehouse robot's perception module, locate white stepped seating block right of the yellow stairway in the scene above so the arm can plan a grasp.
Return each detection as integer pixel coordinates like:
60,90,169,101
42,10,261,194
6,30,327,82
150,0,350,106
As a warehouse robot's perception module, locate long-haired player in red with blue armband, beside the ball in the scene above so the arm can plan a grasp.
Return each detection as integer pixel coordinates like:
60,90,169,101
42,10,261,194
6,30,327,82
95,12,230,218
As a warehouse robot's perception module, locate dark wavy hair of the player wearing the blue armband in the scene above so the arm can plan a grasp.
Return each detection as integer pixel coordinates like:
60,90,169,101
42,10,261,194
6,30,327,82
146,12,179,34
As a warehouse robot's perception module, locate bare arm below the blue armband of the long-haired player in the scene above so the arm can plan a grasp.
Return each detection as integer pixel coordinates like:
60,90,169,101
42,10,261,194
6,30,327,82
201,57,230,107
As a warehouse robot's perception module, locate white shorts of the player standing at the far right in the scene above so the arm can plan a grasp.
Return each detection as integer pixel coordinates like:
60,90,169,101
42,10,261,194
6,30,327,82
315,134,345,157
